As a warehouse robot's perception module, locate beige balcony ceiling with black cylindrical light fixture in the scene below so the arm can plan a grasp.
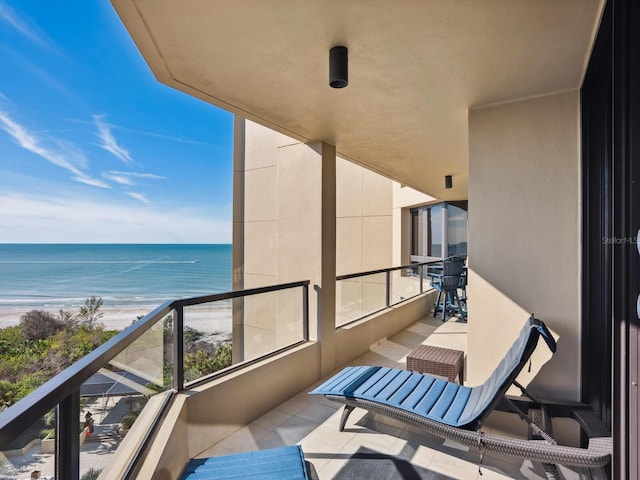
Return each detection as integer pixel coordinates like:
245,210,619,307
112,0,604,199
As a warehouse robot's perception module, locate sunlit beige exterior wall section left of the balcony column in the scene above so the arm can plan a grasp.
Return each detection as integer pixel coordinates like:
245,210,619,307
233,118,322,361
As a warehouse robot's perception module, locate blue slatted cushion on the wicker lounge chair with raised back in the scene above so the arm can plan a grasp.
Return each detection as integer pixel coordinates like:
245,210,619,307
309,315,555,430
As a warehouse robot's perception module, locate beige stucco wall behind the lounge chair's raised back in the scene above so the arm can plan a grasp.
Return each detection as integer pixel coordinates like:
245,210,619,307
467,91,581,399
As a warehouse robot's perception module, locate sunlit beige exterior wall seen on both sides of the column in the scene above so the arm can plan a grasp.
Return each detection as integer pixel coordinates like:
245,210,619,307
233,118,400,352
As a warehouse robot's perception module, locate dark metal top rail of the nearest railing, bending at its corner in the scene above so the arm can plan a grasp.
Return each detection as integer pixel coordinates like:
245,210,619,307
0,280,310,449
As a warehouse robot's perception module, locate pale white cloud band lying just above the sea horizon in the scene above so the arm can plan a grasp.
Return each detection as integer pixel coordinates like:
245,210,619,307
0,194,231,243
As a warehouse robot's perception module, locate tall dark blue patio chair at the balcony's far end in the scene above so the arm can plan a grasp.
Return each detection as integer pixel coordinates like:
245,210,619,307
429,256,466,322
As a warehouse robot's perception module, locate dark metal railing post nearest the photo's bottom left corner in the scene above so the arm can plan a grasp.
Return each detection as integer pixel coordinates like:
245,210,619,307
55,390,80,480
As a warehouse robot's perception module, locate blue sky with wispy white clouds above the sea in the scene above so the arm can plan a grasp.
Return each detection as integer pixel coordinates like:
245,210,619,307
0,0,233,243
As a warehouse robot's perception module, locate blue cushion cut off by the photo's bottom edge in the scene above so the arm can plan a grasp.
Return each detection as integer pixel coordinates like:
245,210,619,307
180,445,308,480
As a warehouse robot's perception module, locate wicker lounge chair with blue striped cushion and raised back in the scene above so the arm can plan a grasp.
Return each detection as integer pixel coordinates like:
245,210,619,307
309,315,612,478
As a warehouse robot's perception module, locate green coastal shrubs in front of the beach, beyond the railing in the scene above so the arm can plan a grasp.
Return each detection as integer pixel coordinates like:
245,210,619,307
0,296,232,411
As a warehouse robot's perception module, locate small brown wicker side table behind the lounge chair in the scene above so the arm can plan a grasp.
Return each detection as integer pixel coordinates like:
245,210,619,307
407,345,464,385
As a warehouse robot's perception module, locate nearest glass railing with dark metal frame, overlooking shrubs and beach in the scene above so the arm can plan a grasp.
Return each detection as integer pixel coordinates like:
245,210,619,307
0,281,309,480
